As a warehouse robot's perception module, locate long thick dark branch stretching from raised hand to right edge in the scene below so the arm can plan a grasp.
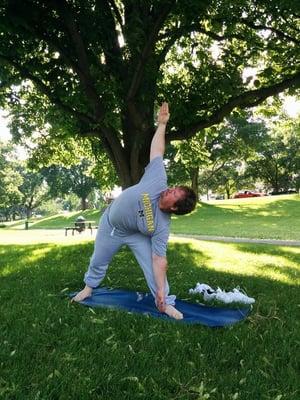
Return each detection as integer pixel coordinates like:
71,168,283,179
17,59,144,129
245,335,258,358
167,72,300,141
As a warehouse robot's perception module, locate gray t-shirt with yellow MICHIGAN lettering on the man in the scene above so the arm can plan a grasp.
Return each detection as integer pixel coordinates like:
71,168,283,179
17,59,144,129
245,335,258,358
109,156,171,256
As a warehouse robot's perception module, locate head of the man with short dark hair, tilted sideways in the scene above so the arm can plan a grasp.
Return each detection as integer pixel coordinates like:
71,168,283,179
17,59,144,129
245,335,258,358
158,186,197,215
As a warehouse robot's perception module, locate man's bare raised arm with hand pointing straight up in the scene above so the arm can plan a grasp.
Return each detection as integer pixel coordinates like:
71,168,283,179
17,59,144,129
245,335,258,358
150,103,170,161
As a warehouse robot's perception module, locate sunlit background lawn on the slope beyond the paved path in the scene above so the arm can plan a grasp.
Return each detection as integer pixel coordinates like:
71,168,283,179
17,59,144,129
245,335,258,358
4,195,300,240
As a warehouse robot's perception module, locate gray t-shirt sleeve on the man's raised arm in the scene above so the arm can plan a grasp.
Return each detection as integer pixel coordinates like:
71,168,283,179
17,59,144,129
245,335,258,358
139,156,167,191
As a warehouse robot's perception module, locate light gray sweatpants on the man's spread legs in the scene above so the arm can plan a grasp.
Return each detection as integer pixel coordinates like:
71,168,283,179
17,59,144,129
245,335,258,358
84,209,176,305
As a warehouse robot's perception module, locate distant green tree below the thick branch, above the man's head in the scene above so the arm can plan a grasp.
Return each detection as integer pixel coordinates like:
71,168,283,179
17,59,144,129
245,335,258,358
167,112,266,196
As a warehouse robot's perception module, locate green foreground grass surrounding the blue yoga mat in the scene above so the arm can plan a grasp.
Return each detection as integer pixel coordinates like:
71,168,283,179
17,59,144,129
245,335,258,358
0,239,300,400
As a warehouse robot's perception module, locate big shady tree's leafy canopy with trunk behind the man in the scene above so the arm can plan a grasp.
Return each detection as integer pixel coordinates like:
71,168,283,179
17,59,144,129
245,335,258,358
0,0,300,187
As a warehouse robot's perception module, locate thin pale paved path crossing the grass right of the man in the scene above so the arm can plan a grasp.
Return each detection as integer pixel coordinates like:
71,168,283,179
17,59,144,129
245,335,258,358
171,233,300,246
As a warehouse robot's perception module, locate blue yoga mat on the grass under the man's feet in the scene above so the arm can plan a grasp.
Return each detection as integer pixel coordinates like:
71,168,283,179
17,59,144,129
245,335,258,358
69,287,251,327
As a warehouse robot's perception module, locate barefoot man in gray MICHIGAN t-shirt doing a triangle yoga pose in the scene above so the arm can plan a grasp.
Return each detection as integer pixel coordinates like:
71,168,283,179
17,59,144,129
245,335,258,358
72,103,196,319
